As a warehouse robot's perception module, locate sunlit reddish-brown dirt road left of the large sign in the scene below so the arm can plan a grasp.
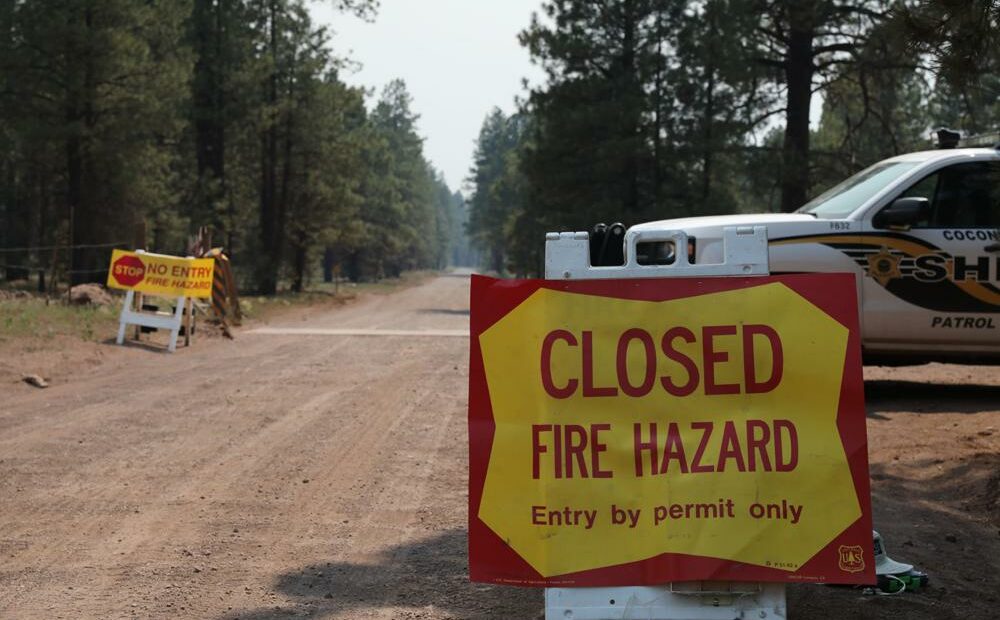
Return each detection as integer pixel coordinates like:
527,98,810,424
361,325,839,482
0,278,539,618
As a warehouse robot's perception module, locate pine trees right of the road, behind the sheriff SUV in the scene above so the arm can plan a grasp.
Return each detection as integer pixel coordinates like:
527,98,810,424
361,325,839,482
469,0,1000,275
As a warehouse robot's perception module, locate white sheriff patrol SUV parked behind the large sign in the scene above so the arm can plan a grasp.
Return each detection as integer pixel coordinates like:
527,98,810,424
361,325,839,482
633,145,1000,364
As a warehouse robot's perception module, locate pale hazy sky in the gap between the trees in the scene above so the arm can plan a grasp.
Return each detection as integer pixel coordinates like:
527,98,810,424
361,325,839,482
310,0,541,190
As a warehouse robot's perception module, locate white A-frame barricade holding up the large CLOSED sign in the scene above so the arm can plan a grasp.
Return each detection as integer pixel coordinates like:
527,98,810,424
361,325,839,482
545,226,786,620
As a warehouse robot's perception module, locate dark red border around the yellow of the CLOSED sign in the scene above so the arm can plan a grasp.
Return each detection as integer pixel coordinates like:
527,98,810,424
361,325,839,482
469,273,875,587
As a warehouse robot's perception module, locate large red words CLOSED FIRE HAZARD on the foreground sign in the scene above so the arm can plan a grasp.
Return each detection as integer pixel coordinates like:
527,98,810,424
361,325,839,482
531,325,799,480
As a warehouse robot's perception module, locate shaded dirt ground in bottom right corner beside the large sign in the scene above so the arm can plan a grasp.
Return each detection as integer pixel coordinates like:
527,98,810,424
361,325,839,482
788,453,1000,620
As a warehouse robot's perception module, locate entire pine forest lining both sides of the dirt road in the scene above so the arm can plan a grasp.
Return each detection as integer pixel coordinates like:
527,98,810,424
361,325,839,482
0,0,1000,294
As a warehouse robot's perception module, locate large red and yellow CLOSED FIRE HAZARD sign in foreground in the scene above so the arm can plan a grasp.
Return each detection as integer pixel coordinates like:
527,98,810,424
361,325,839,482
469,274,874,586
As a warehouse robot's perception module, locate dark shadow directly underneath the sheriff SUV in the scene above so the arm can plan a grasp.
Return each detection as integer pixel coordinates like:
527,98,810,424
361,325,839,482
865,381,1000,418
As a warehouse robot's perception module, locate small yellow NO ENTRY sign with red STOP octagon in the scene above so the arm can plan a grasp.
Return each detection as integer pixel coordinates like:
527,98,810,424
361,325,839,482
108,250,215,298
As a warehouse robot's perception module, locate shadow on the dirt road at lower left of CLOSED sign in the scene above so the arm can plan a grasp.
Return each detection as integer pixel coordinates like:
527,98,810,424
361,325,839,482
222,530,543,620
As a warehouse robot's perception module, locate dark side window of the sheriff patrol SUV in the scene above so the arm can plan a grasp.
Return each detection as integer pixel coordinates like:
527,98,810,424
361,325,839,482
901,162,1000,228
